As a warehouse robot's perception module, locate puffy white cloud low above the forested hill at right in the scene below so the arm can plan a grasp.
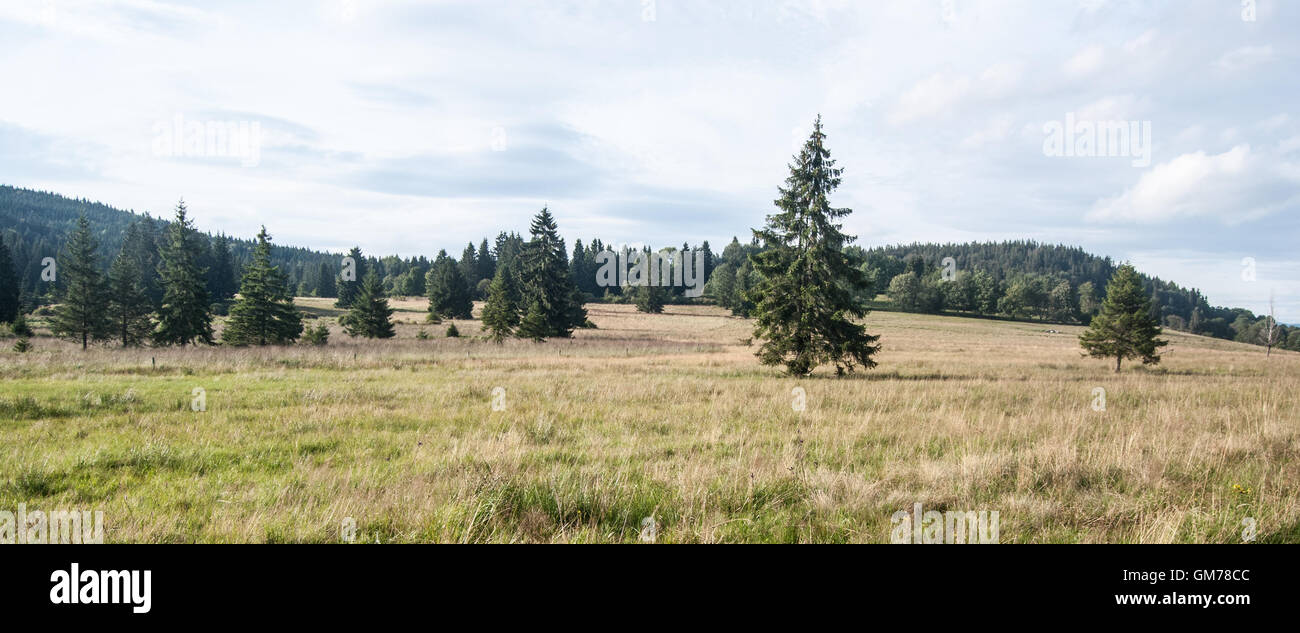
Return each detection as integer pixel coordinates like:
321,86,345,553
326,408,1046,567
1087,144,1300,225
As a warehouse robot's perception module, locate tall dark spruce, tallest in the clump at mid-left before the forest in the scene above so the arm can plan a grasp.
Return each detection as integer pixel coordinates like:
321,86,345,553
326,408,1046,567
520,207,586,338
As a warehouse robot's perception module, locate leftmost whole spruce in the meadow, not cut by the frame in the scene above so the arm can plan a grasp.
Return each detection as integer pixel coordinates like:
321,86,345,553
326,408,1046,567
49,216,109,350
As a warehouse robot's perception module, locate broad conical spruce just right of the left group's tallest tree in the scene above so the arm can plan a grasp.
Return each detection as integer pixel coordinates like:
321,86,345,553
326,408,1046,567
221,226,303,346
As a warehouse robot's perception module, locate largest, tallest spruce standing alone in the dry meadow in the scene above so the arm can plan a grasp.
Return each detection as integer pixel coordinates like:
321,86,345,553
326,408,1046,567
749,116,880,376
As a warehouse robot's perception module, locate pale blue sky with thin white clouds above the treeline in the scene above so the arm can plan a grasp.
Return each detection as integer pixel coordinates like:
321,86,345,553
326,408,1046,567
0,0,1300,324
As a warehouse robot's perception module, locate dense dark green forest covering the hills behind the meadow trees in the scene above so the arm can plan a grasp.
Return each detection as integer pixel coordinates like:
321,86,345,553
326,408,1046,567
0,186,1300,351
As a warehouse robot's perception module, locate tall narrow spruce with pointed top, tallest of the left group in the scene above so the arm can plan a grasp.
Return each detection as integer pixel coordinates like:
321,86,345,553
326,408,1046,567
153,200,213,346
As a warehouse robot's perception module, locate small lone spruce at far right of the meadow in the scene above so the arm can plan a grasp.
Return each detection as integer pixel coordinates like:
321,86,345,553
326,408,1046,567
1079,264,1169,373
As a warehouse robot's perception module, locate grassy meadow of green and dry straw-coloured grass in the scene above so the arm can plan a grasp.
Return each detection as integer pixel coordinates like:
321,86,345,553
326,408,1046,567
0,299,1300,543
